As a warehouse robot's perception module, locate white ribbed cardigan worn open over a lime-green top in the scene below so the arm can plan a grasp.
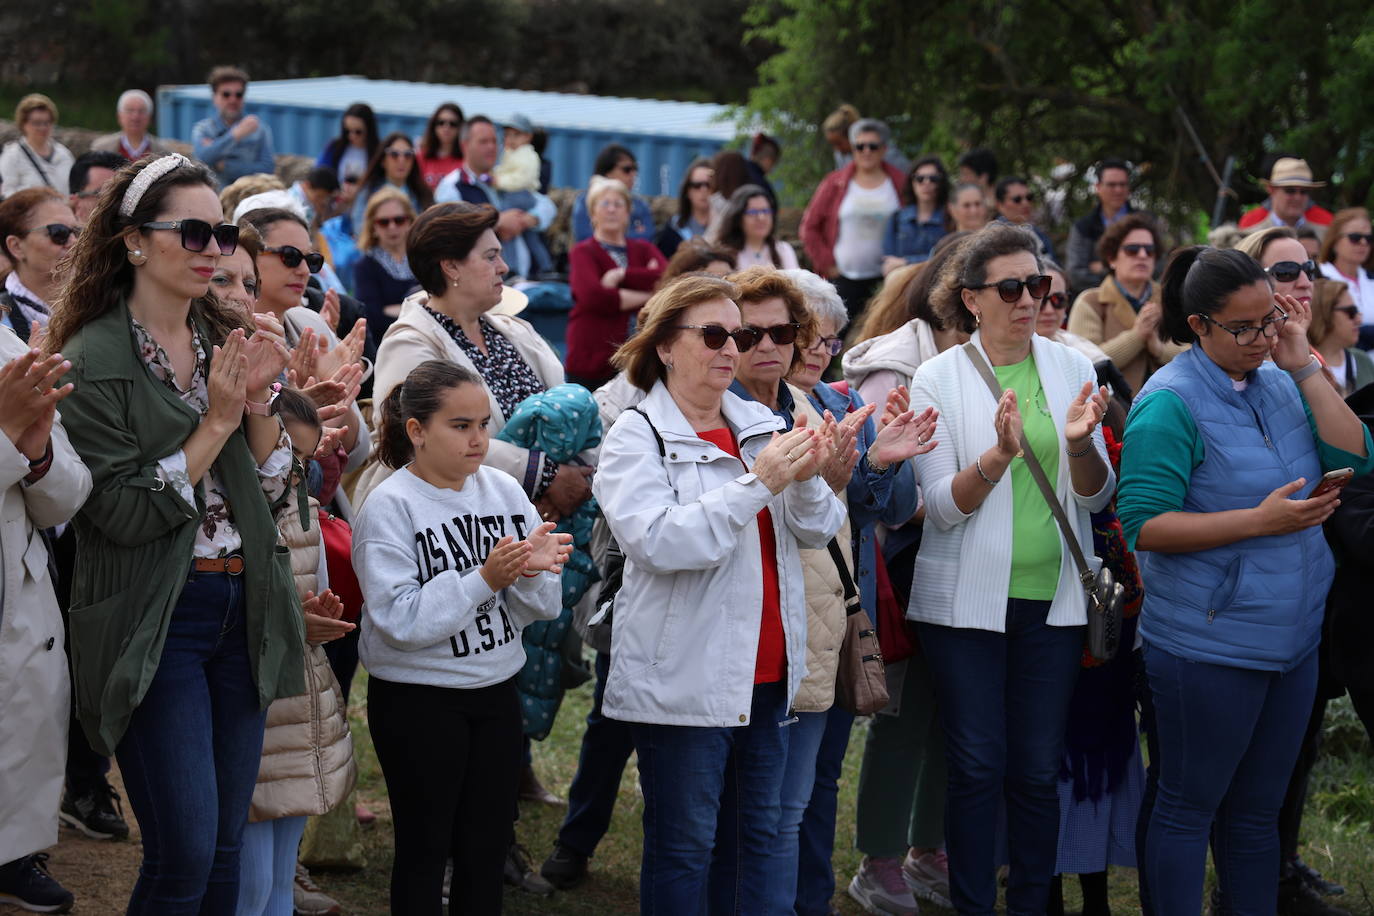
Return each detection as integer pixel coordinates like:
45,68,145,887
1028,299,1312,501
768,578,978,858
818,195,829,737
907,334,1116,633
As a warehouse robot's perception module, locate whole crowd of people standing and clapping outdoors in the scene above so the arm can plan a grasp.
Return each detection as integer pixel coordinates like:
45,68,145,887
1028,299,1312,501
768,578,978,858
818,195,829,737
0,67,1374,916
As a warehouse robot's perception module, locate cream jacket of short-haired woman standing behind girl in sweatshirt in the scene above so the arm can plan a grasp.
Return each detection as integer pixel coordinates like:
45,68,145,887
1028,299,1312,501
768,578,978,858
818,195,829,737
353,291,563,511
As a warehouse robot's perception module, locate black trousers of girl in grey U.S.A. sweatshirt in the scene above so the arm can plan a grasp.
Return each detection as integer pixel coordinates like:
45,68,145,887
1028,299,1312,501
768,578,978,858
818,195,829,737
367,676,522,916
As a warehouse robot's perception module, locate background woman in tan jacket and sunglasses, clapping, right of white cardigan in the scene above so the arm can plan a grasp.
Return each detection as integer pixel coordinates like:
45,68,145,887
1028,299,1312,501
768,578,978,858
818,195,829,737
1069,213,1183,391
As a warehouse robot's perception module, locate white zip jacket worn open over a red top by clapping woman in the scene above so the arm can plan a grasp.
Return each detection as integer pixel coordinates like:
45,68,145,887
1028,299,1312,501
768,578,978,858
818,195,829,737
592,382,845,728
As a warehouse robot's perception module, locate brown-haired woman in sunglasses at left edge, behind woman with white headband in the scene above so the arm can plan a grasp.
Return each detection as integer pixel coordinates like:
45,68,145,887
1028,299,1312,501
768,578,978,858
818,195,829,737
0,188,80,341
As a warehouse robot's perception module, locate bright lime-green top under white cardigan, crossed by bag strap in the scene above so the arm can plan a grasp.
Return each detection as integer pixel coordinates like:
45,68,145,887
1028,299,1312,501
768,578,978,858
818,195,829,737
993,356,1062,602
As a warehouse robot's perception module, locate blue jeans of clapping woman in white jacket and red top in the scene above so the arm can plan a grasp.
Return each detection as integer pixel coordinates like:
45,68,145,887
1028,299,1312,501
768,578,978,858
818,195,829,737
631,683,791,916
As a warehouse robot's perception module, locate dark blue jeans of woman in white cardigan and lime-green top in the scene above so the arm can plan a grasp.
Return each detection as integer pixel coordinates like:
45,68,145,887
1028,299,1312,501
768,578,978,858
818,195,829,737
921,601,1084,916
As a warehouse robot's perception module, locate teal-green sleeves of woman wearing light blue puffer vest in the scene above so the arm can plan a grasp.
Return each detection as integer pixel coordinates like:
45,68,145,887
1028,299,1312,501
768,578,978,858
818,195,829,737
1117,389,1374,551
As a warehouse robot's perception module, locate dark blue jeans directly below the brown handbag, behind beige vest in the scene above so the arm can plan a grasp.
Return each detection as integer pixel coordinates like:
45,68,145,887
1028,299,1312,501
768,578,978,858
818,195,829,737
783,705,855,916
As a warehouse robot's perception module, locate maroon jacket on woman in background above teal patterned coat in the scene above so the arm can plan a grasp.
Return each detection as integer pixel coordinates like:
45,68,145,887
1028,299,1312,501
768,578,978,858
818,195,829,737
563,238,668,379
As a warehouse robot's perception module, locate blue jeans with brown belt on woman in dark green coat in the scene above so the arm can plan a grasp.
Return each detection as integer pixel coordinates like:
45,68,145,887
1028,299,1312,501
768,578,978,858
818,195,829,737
115,573,267,916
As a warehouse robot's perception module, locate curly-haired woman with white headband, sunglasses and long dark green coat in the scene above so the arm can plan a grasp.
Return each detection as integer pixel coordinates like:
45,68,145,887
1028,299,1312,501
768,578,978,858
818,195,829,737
44,154,304,913
